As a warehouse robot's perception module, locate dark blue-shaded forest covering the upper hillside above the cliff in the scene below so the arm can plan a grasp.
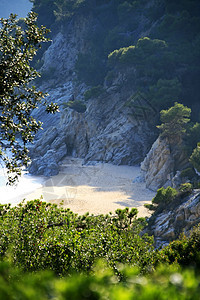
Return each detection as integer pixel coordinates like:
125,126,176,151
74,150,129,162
32,0,200,120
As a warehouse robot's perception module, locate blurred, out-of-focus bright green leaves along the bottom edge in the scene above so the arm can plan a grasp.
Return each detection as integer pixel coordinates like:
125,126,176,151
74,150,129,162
0,261,200,300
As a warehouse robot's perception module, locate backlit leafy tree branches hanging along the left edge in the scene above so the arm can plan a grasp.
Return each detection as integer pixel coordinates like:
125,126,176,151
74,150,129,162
0,13,58,182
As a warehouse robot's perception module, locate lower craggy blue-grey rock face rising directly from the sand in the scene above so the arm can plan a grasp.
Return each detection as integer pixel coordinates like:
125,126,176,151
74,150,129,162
29,84,154,176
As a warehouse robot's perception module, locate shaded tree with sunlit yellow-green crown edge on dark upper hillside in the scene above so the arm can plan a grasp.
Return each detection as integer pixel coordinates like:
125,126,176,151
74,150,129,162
108,37,179,86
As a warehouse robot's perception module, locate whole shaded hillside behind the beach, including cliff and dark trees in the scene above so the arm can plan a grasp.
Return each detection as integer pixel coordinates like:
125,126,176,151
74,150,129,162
27,0,200,184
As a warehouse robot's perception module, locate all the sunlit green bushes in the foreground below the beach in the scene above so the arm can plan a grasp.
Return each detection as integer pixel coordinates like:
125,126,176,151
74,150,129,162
0,200,200,300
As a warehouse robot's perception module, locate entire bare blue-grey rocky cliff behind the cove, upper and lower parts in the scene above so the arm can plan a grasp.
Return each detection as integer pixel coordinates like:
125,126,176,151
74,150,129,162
29,12,155,176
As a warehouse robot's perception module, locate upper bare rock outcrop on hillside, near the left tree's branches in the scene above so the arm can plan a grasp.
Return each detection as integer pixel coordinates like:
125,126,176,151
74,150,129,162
41,15,93,87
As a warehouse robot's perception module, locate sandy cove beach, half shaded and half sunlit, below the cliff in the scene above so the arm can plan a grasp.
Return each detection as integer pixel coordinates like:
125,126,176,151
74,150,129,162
24,157,155,217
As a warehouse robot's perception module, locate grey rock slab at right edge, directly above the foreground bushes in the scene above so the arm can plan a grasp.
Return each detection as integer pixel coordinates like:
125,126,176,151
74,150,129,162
145,190,200,247
